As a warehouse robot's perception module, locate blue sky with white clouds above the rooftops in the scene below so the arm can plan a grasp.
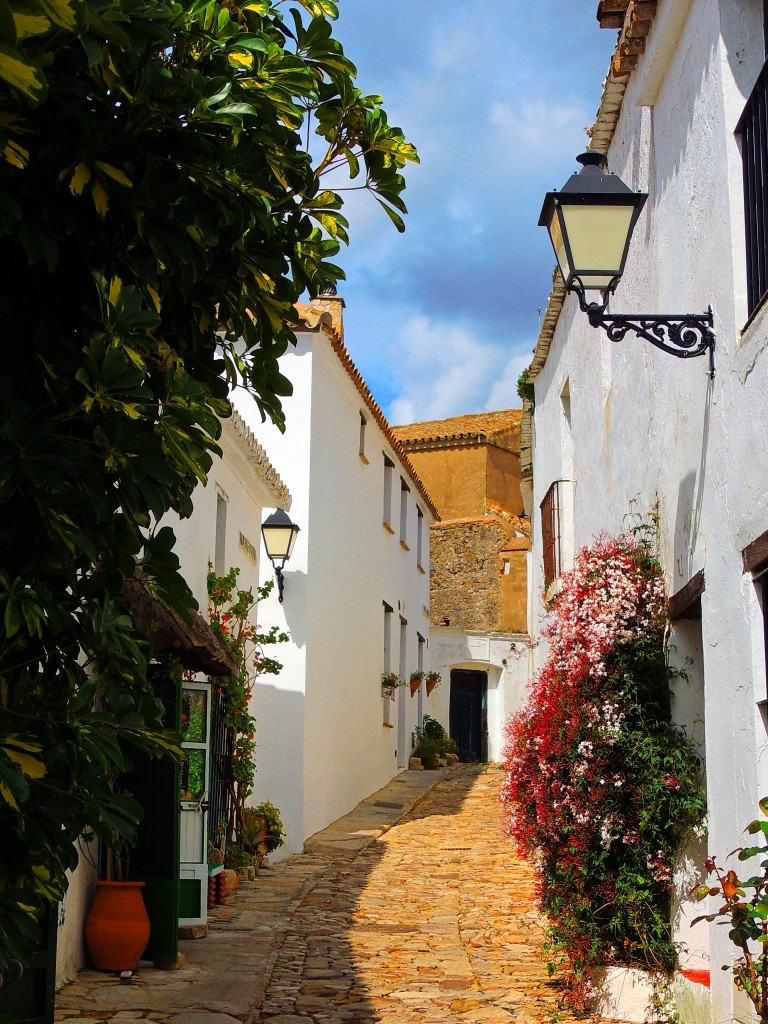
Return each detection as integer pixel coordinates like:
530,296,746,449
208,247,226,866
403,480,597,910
315,0,615,424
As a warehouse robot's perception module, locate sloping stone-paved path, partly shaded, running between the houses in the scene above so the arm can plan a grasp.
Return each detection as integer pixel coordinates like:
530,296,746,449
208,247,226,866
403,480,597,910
56,766,610,1024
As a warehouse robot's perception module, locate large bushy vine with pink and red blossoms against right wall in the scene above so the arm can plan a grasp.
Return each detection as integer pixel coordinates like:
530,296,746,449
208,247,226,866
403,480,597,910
501,535,705,1007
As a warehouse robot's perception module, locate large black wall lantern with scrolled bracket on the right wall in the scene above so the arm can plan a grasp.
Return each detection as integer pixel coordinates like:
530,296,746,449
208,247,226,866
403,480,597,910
539,152,715,377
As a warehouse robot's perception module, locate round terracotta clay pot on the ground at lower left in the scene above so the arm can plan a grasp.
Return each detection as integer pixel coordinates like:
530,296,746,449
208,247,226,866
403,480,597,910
85,882,150,971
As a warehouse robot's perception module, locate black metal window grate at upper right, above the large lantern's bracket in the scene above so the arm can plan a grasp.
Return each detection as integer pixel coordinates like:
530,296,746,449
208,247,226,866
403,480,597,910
736,61,768,316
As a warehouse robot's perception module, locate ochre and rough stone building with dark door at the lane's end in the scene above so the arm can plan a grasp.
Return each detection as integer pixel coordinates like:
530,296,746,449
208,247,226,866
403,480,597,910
392,409,530,760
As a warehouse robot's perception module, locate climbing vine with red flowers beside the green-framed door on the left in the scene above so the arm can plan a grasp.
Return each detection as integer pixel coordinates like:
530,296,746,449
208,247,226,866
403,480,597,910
208,566,289,853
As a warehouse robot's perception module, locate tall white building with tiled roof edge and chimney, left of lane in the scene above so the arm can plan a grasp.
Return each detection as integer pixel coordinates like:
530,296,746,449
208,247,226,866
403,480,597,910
237,296,437,858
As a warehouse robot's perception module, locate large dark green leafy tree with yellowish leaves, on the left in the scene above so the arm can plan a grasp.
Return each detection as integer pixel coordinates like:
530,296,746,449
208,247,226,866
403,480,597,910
0,0,416,971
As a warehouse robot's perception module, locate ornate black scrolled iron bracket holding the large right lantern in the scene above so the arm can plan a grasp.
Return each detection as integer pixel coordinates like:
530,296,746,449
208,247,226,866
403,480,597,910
570,278,715,380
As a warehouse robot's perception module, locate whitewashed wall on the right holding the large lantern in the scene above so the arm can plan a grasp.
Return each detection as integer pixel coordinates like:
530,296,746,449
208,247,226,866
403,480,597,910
532,0,768,1020
